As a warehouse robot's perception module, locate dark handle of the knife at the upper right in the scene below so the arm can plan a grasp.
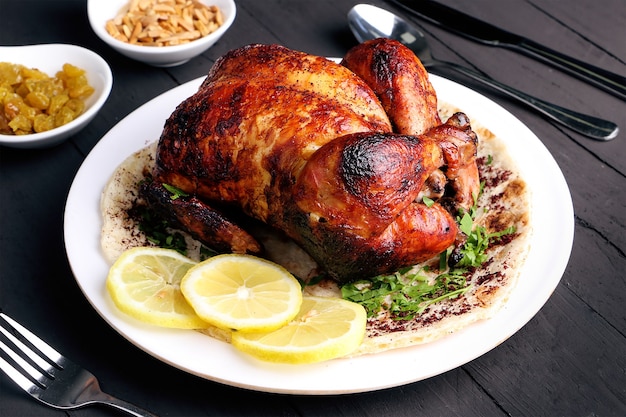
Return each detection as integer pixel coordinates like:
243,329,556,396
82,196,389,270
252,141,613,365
503,39,626,100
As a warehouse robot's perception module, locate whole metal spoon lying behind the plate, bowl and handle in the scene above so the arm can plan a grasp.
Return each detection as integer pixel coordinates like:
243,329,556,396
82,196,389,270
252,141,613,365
348,4,619,141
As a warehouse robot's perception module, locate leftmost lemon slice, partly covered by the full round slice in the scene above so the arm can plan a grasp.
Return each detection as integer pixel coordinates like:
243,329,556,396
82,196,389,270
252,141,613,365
106,247,209,329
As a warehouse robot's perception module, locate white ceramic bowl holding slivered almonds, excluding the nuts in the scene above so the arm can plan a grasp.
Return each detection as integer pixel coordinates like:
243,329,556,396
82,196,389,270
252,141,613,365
87,0,236,67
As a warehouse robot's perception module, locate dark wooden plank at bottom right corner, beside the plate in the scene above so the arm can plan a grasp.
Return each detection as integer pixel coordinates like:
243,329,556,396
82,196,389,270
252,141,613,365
465,286,626,416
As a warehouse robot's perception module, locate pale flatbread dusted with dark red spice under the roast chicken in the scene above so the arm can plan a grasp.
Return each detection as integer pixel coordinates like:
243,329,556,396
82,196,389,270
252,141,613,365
101,104,532,356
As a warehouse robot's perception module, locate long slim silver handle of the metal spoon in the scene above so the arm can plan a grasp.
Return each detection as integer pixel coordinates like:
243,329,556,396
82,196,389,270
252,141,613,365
429,61,619,141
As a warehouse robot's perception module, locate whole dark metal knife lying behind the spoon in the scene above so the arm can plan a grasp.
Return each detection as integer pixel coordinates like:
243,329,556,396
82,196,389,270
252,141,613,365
388,0,626,100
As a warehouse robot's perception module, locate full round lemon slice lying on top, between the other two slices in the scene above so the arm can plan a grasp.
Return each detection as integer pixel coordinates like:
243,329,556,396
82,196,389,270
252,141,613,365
180,254,302,331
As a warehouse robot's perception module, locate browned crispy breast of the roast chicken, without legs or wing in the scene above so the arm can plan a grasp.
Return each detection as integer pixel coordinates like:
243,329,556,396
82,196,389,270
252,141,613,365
156,45,391,222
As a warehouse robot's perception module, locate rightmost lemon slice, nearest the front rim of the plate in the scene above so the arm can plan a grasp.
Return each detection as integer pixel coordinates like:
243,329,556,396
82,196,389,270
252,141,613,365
232,296,367,364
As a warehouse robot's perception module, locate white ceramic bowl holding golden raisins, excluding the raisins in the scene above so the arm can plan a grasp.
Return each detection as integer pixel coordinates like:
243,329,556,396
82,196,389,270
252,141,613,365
0,44,113,148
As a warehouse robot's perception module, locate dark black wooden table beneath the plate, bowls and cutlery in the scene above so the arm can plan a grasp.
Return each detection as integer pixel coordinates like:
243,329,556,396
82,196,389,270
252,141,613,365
0,0,626,417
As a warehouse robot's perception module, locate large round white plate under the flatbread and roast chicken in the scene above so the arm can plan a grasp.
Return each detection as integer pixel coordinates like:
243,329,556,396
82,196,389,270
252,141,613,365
65,75,574,394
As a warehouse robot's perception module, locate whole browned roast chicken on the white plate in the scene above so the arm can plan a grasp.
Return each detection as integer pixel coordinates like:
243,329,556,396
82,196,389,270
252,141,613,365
143,39,479,281
